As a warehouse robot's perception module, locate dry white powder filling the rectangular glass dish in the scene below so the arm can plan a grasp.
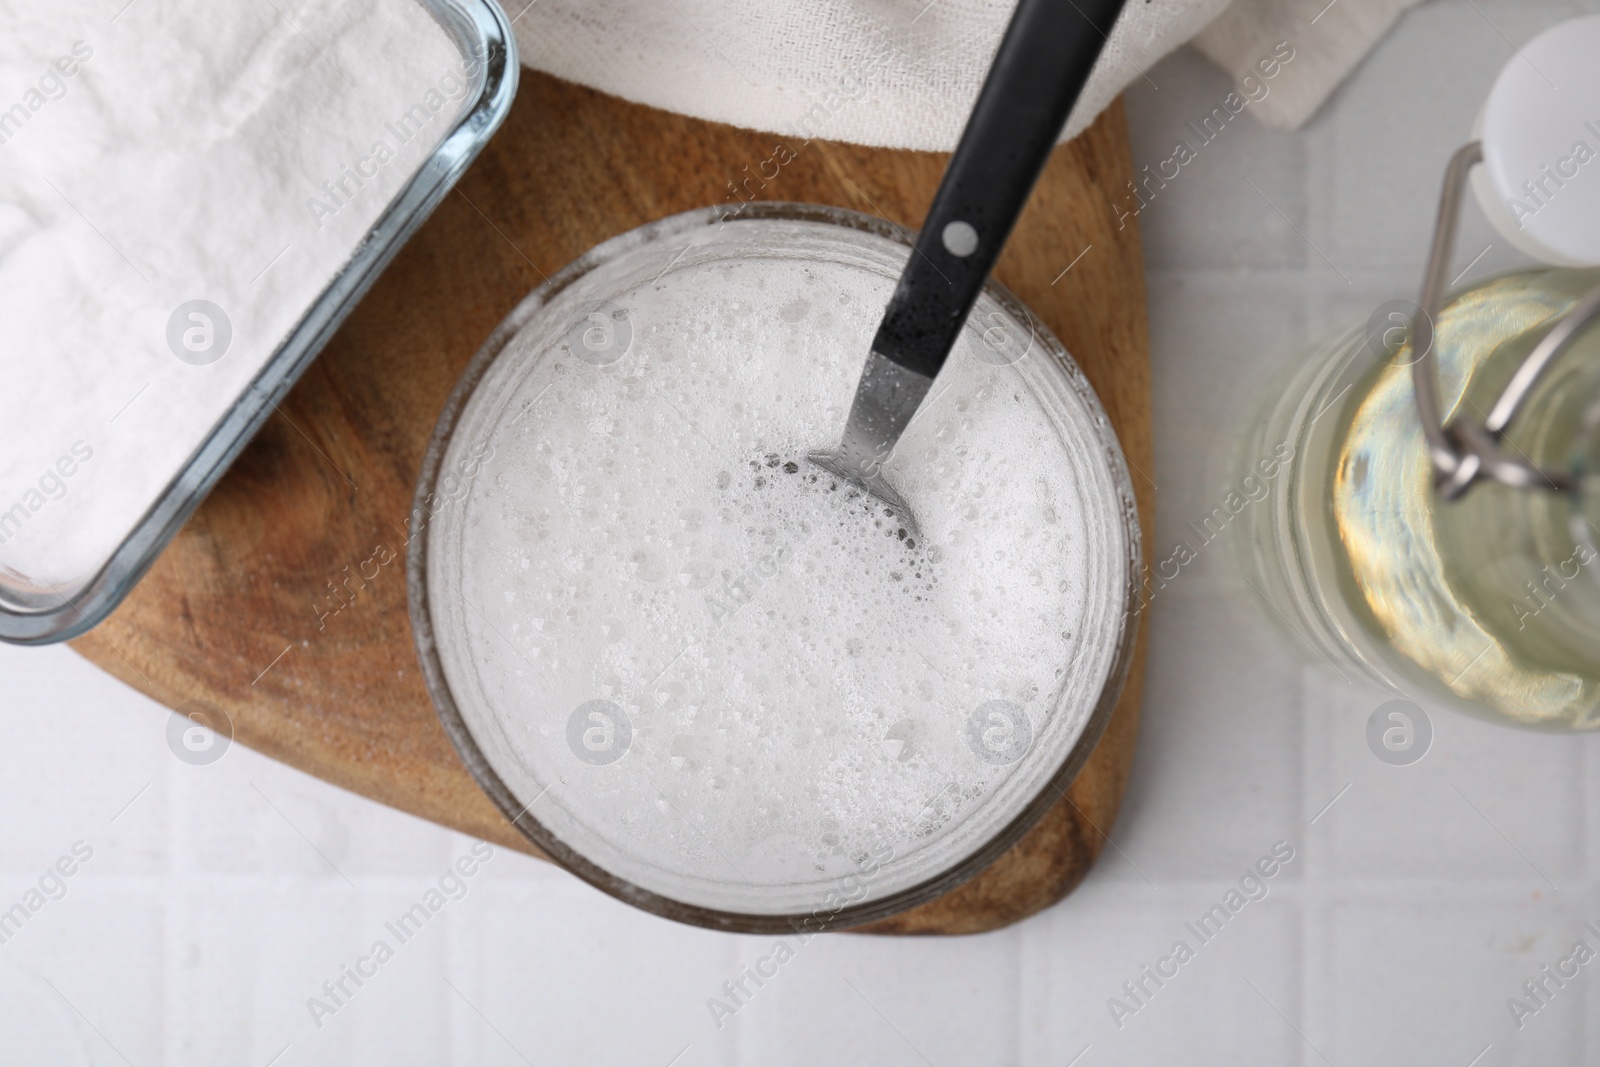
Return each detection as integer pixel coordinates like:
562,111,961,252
0,0,464,590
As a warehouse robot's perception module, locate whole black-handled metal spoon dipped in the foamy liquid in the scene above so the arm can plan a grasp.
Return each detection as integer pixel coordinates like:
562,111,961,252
810,0,1125,528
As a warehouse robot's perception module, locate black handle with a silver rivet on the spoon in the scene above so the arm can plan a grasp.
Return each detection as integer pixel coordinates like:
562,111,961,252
872,0,1125,379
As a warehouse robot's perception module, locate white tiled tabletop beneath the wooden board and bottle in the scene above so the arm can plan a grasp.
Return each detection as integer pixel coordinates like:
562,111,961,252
0,0,1600,1067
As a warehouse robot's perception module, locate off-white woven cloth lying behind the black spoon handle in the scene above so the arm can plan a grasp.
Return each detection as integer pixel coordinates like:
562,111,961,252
507,0,1416,150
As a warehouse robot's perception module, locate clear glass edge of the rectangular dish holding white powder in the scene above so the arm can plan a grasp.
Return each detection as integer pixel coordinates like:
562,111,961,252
0,0,520,645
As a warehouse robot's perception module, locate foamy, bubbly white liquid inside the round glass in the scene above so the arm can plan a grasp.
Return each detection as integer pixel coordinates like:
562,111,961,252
426,221,1130,915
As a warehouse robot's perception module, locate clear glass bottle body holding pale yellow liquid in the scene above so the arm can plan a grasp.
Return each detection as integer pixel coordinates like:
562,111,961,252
1240,269,1600,729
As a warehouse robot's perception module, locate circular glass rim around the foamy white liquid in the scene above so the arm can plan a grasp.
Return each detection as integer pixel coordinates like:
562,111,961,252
406,202,1142,934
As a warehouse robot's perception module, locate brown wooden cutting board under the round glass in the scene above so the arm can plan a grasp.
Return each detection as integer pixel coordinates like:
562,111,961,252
74,70,1154,933
